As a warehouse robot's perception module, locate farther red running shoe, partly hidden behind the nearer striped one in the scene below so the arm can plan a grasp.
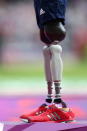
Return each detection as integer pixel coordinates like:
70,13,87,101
20,104,48,122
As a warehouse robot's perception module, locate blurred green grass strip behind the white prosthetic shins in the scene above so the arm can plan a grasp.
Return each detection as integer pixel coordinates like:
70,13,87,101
0,61,87,80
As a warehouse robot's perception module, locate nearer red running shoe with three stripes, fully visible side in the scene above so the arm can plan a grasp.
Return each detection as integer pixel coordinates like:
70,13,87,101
28,105,75,123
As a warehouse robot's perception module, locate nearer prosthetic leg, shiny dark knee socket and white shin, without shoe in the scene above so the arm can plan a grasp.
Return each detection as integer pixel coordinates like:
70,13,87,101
44,21,66,107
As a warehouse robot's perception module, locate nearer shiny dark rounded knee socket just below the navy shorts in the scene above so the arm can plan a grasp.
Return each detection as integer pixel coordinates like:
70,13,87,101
44,21,66,42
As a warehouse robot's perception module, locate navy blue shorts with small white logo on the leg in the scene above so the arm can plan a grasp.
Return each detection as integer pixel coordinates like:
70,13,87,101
34,0,67,28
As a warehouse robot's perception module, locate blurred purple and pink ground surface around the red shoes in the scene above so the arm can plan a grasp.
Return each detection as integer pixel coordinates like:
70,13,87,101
0,96,87,131
